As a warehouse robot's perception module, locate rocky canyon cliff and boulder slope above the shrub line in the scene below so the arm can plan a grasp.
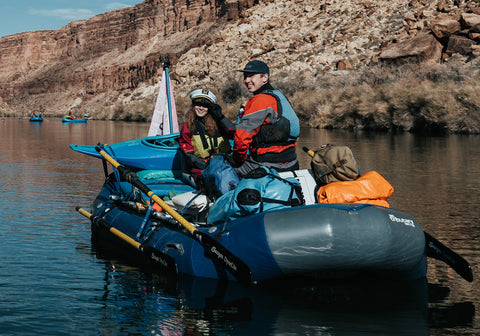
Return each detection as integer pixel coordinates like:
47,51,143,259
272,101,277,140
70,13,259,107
0,0,480,118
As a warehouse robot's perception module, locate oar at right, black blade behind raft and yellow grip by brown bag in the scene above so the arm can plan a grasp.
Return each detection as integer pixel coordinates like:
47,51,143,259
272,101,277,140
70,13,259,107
303,147,473,282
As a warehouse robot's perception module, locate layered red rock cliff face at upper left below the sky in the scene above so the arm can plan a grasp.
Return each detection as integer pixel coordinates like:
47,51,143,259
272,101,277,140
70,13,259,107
0,0,253,115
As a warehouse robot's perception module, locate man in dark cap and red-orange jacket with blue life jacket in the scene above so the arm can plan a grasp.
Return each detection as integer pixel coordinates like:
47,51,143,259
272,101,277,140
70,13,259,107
233,60,300,176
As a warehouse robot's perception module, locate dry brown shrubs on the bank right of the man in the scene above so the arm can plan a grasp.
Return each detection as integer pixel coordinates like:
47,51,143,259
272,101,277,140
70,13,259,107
286,64,480,134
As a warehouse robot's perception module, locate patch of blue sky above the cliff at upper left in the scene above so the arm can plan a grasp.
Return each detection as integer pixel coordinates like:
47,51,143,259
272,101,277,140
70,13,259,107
0,0,143,37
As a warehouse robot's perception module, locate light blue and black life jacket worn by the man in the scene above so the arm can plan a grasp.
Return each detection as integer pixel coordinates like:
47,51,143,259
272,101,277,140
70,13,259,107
255,89,300,147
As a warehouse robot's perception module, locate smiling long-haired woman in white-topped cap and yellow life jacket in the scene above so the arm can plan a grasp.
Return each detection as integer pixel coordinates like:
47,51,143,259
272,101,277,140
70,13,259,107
179,89,235,182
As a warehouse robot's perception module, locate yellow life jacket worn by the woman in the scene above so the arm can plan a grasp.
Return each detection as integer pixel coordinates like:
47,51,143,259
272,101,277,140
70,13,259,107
192,120,231,159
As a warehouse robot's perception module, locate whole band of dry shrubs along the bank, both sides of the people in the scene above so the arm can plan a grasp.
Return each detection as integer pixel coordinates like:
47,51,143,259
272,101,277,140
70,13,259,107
82,60,480,133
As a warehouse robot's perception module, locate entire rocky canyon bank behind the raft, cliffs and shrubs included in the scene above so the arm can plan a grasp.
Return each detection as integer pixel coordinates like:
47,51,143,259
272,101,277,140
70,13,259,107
0,0,480,134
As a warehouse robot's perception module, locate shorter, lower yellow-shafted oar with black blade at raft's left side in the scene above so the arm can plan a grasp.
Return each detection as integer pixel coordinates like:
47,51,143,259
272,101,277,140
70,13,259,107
75,207,177,276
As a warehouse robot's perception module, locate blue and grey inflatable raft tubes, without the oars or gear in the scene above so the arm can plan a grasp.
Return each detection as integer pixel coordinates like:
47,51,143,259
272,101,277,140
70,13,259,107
82,171,426,282
